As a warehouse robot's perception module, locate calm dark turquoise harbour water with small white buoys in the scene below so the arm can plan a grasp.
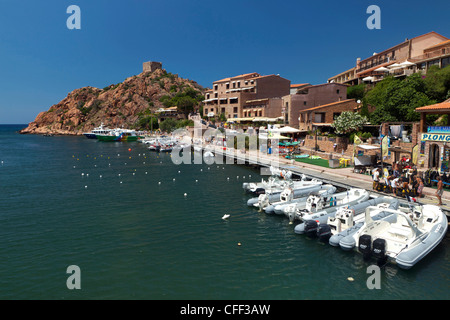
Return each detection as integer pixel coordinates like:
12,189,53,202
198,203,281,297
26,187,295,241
0,126,450,300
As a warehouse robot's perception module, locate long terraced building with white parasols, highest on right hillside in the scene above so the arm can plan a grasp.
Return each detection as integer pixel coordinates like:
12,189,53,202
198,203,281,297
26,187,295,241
328,31,450,85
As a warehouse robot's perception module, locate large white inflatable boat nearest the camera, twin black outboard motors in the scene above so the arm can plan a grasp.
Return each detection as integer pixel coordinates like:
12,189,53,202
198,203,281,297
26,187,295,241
340,205,448,269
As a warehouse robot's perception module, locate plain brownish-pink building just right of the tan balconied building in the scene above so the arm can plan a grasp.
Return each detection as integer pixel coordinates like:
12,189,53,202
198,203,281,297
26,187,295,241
281,83,347,128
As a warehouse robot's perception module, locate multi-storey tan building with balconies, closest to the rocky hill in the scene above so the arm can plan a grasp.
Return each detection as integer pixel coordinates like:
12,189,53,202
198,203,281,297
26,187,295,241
203,72,291,119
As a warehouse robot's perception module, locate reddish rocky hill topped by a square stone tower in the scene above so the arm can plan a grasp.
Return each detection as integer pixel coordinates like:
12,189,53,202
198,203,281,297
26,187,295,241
21,69,204,135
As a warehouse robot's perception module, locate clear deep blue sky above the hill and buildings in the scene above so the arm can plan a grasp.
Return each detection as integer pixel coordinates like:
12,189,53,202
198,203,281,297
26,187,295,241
0,0,450,124
